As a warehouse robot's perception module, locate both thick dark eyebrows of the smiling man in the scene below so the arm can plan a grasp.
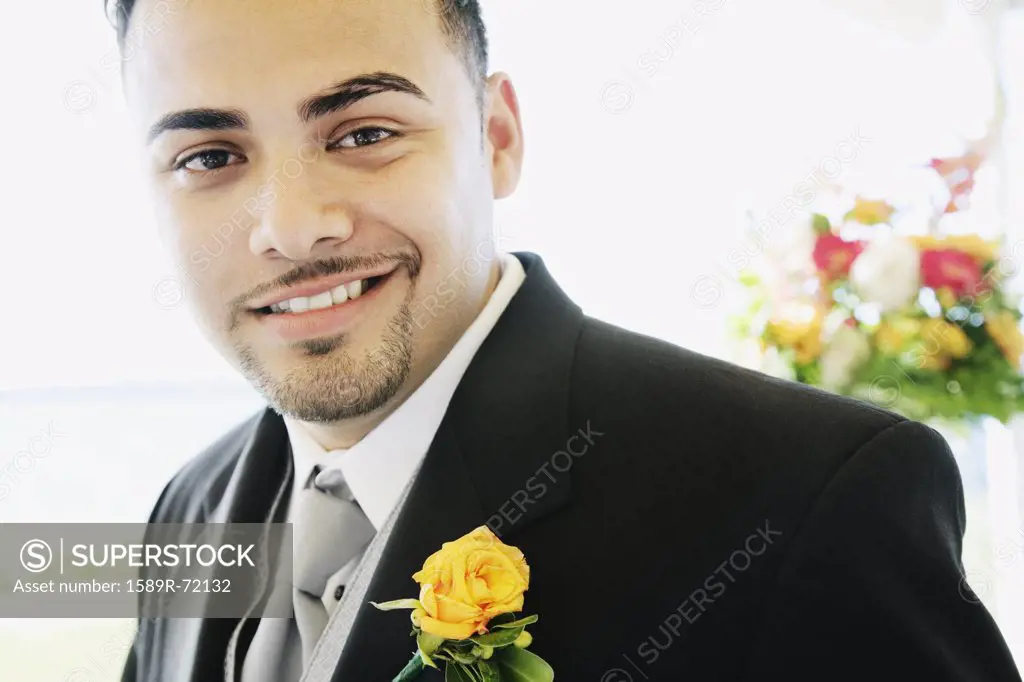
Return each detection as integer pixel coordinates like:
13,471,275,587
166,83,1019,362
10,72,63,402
146,72,430,144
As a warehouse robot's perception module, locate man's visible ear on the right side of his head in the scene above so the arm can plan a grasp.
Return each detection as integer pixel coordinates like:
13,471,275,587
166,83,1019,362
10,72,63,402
486,72,523,199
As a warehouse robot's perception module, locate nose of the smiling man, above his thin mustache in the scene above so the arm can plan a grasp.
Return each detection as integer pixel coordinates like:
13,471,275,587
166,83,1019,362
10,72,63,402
249,170,352,261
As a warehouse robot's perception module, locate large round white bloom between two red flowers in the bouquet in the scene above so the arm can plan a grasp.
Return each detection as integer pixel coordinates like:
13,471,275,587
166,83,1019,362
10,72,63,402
850,233,921,311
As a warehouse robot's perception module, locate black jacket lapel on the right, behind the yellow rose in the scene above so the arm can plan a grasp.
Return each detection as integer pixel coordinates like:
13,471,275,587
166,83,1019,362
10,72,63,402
332,254,583,682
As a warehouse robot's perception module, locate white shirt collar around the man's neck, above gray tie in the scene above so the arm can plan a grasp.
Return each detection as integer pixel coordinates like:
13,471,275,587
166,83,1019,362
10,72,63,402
285,253,526,529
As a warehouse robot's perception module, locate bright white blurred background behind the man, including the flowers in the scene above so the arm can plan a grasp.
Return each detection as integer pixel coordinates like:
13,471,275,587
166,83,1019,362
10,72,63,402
0,0,1024,671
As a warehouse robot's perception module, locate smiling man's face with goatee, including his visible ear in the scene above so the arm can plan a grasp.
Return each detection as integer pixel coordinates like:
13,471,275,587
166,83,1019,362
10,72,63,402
124,0,520,422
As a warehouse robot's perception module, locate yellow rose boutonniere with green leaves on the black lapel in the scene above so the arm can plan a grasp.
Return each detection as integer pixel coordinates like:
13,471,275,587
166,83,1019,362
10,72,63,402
371,525,555,682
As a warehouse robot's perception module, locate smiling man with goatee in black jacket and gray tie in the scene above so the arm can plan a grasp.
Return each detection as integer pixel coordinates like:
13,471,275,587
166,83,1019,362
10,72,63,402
112,0,1020,682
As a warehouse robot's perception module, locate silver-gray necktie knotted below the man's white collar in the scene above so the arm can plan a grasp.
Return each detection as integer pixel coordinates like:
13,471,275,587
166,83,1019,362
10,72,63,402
242,468,376,682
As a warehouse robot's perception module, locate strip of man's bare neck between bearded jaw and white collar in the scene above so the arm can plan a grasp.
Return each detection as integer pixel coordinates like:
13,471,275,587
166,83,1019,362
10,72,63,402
302,258,501,450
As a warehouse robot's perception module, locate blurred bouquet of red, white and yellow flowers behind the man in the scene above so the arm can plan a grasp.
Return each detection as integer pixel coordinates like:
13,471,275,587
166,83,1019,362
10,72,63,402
736,152,1024,423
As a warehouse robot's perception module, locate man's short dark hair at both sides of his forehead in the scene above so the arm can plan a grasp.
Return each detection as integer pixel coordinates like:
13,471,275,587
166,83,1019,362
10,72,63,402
103,0,487,103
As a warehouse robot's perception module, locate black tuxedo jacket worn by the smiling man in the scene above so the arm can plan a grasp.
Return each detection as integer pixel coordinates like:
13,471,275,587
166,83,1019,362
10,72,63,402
124,253,1021,682
